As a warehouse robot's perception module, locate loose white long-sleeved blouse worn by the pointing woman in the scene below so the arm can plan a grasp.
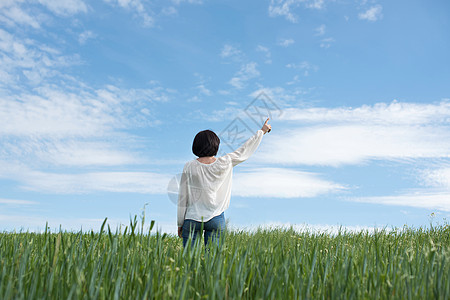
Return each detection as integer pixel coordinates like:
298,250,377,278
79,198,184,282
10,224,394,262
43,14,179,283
177,129,264,227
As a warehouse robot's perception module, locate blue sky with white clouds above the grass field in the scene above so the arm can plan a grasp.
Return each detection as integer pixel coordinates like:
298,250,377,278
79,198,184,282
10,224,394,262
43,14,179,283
0,0,450,233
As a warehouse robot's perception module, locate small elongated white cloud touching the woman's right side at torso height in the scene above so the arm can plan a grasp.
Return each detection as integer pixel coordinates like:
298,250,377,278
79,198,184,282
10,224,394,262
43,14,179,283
232,168,345,198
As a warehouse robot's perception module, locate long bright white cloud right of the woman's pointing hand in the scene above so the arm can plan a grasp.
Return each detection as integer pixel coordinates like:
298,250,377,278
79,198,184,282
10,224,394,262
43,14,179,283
259,125,450,166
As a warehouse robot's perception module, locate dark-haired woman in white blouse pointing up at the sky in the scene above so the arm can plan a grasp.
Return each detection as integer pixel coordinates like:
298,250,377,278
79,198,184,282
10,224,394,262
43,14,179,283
178,118,272,246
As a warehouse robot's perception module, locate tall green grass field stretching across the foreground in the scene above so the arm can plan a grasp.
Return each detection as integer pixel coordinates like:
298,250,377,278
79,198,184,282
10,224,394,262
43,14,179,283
0,219,450,299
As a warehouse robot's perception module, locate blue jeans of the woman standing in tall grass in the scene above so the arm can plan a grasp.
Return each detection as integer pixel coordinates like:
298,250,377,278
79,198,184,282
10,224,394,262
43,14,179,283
181,213,225,247
